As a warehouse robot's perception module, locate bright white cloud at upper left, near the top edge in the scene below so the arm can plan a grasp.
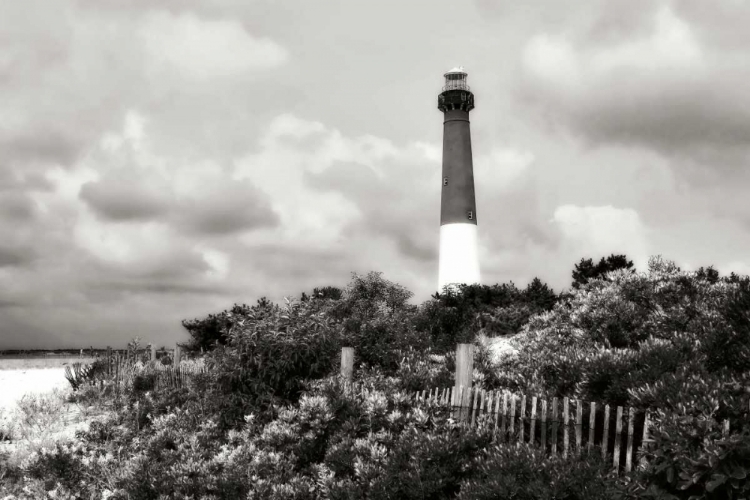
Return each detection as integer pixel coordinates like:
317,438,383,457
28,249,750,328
139,11,289,79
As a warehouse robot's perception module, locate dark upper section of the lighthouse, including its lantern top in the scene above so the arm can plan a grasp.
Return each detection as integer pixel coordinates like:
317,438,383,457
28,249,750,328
438,68,477,225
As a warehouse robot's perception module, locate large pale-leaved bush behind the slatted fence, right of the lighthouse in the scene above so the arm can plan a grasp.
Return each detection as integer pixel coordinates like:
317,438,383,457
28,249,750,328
499,258,750,405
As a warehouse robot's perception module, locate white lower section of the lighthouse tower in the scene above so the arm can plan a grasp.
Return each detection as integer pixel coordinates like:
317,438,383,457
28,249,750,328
438,223,479,292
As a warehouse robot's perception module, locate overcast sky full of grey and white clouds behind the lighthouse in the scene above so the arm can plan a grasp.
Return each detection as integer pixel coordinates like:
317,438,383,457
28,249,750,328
0,0,750,348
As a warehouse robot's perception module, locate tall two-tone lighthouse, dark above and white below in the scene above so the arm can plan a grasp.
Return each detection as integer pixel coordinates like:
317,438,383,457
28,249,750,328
438,68,479,292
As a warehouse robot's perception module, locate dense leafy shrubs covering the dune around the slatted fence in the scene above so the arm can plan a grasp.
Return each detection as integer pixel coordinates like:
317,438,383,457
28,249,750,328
0,256,750,499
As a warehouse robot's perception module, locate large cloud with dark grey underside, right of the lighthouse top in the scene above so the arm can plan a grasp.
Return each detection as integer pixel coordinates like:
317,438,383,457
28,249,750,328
522,4,750,154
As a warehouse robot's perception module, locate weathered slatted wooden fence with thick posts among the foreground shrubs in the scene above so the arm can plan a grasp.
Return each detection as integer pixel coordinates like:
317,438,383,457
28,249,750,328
341,344,740,473
